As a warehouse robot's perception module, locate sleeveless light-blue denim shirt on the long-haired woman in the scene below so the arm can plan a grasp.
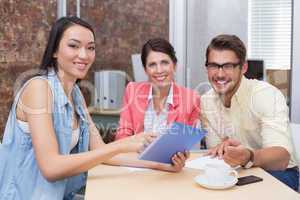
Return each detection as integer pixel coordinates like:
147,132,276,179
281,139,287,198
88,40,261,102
0,71,89,200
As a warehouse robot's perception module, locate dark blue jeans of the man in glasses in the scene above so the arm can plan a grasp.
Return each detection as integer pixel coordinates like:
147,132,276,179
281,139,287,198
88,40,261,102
267,167,299,191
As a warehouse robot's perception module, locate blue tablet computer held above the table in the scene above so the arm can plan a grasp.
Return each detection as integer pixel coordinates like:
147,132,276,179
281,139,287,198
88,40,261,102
139,122,207,164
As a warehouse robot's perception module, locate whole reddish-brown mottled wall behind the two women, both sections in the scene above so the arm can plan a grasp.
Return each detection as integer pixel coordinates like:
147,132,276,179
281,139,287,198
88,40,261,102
0,0,169,138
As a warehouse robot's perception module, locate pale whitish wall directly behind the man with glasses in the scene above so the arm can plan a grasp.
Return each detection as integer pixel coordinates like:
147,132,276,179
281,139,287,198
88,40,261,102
186,0,248,88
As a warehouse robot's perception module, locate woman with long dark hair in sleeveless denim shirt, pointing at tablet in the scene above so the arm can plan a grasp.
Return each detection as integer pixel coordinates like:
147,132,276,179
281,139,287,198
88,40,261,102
0,17,185,200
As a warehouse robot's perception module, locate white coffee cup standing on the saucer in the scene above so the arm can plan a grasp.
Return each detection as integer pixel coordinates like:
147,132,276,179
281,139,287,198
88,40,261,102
203,163,238,185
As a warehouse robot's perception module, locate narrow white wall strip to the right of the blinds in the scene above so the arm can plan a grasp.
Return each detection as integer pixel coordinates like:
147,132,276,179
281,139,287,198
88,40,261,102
290,0,300,123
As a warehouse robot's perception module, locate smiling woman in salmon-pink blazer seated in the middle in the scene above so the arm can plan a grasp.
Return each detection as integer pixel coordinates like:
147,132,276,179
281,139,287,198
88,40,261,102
116,38,200,140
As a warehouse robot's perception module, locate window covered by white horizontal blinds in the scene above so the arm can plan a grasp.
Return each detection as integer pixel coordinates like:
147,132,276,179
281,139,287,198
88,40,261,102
248,0,292,69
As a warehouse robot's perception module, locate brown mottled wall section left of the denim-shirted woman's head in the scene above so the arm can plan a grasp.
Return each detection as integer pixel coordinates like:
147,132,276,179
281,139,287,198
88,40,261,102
0,0,56,138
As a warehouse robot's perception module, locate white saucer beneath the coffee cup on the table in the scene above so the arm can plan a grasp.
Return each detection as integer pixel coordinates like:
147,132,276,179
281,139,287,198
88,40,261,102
194,174,238,190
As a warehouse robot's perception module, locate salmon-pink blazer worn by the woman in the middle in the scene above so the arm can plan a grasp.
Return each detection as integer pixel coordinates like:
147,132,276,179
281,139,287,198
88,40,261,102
116,82,200,139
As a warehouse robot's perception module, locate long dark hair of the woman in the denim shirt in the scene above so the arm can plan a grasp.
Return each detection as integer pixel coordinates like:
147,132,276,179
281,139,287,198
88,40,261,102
39,16,95,75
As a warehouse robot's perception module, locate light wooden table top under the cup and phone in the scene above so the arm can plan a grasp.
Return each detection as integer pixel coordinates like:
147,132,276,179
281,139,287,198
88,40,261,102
85,154,300,200
